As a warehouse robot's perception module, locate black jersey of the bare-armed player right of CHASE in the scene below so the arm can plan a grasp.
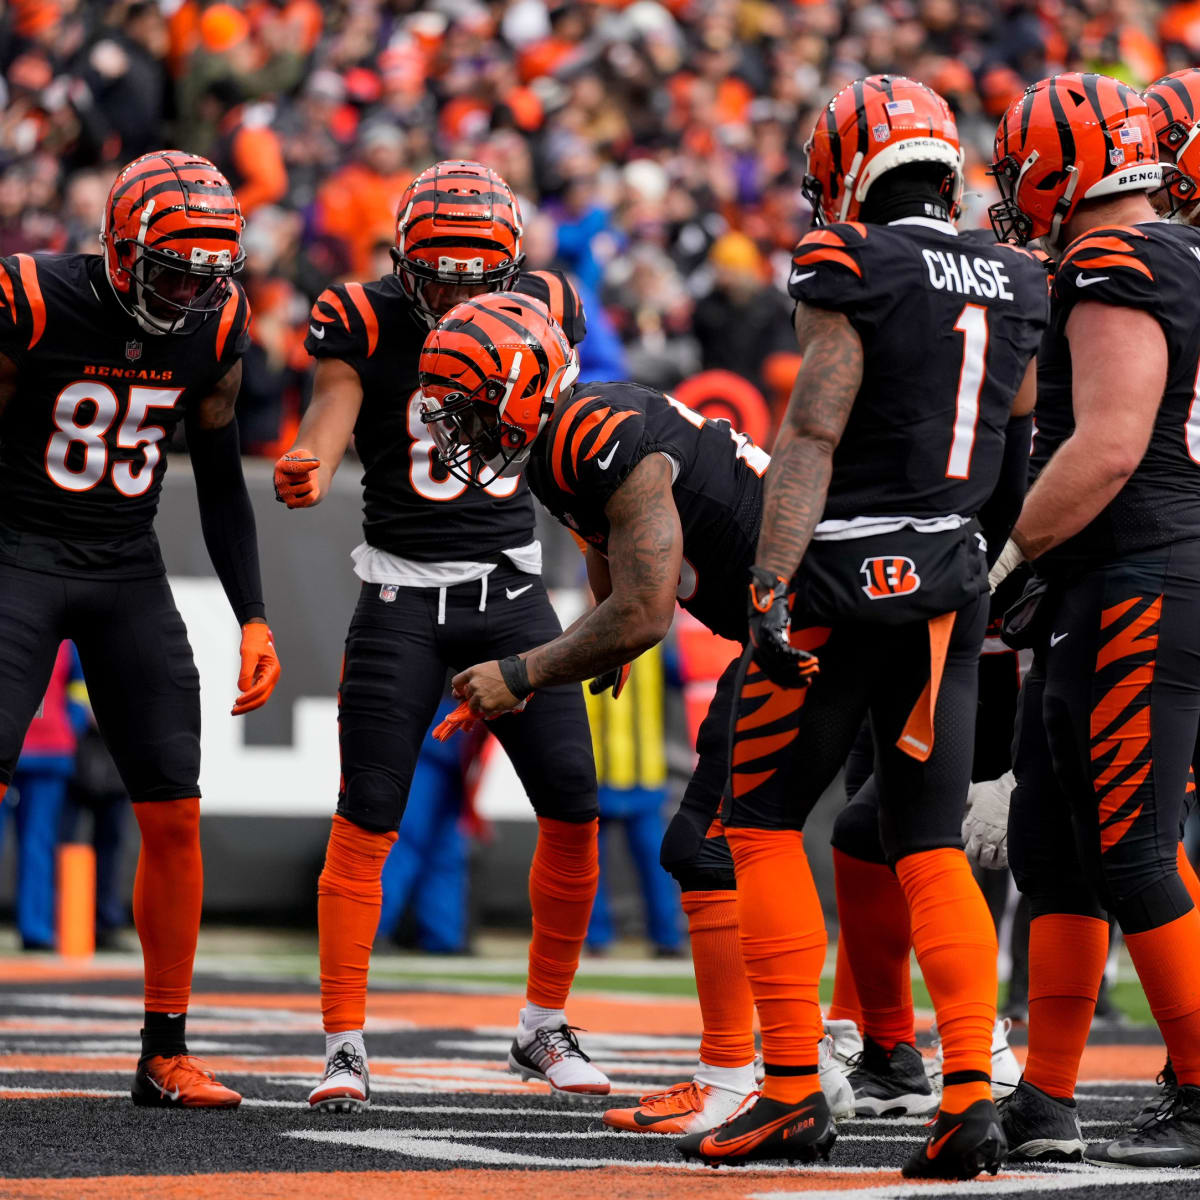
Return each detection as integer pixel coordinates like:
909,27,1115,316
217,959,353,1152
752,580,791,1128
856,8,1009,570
1033,222,1200,576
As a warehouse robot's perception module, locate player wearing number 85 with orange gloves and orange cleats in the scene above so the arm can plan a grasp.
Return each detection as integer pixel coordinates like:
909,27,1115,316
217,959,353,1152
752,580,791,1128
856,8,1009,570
0,150,280,1108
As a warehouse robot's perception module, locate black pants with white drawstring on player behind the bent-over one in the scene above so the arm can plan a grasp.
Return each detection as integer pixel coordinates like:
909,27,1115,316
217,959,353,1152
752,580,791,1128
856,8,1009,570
337,560,599,833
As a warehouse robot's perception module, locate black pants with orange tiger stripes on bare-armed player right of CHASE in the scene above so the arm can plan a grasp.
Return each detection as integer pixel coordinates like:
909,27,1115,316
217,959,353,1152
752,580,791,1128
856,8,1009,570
1008,541,1200,934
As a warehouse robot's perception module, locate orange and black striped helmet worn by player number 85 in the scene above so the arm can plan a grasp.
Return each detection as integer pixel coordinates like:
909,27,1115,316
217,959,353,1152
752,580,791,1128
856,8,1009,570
100,150,246,334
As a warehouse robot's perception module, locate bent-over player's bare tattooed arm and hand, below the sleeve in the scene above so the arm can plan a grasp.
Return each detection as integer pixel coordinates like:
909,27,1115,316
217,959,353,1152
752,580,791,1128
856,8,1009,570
454,454,683,716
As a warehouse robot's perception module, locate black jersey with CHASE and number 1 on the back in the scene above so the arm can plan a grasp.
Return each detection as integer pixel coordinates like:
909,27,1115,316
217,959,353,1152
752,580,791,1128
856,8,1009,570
788,218,1049,520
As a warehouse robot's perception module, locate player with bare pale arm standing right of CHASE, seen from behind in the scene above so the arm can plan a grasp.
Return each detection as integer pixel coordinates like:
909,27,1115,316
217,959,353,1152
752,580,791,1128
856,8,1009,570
994,73,1200,1166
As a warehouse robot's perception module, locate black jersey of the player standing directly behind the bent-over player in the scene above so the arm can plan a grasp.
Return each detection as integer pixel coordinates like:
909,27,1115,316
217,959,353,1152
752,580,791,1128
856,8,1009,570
305,271,587,562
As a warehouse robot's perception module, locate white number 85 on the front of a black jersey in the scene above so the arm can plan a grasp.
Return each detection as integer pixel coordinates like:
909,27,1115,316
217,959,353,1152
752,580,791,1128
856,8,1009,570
46,379,184,497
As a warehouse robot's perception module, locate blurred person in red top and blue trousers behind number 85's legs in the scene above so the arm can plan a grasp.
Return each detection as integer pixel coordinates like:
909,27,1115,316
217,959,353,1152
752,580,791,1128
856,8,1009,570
0,642,90,950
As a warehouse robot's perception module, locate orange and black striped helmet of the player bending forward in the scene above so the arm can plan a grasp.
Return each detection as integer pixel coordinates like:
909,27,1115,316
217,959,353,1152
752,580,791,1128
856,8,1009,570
420,292,580,487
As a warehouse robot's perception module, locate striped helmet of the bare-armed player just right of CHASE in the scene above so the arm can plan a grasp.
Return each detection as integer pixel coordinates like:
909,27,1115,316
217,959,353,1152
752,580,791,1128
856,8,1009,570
989,71,1163,251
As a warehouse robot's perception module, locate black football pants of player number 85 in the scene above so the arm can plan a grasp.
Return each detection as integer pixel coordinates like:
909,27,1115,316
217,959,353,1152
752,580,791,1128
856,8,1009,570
0,564,200,802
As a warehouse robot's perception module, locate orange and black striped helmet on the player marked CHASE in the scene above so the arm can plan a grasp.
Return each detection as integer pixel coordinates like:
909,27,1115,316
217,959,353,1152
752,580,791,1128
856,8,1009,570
804,76,962,224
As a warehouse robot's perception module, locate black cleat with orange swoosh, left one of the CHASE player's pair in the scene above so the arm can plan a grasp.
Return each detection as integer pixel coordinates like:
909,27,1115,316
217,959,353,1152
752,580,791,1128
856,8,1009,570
676,1092,838,1166
